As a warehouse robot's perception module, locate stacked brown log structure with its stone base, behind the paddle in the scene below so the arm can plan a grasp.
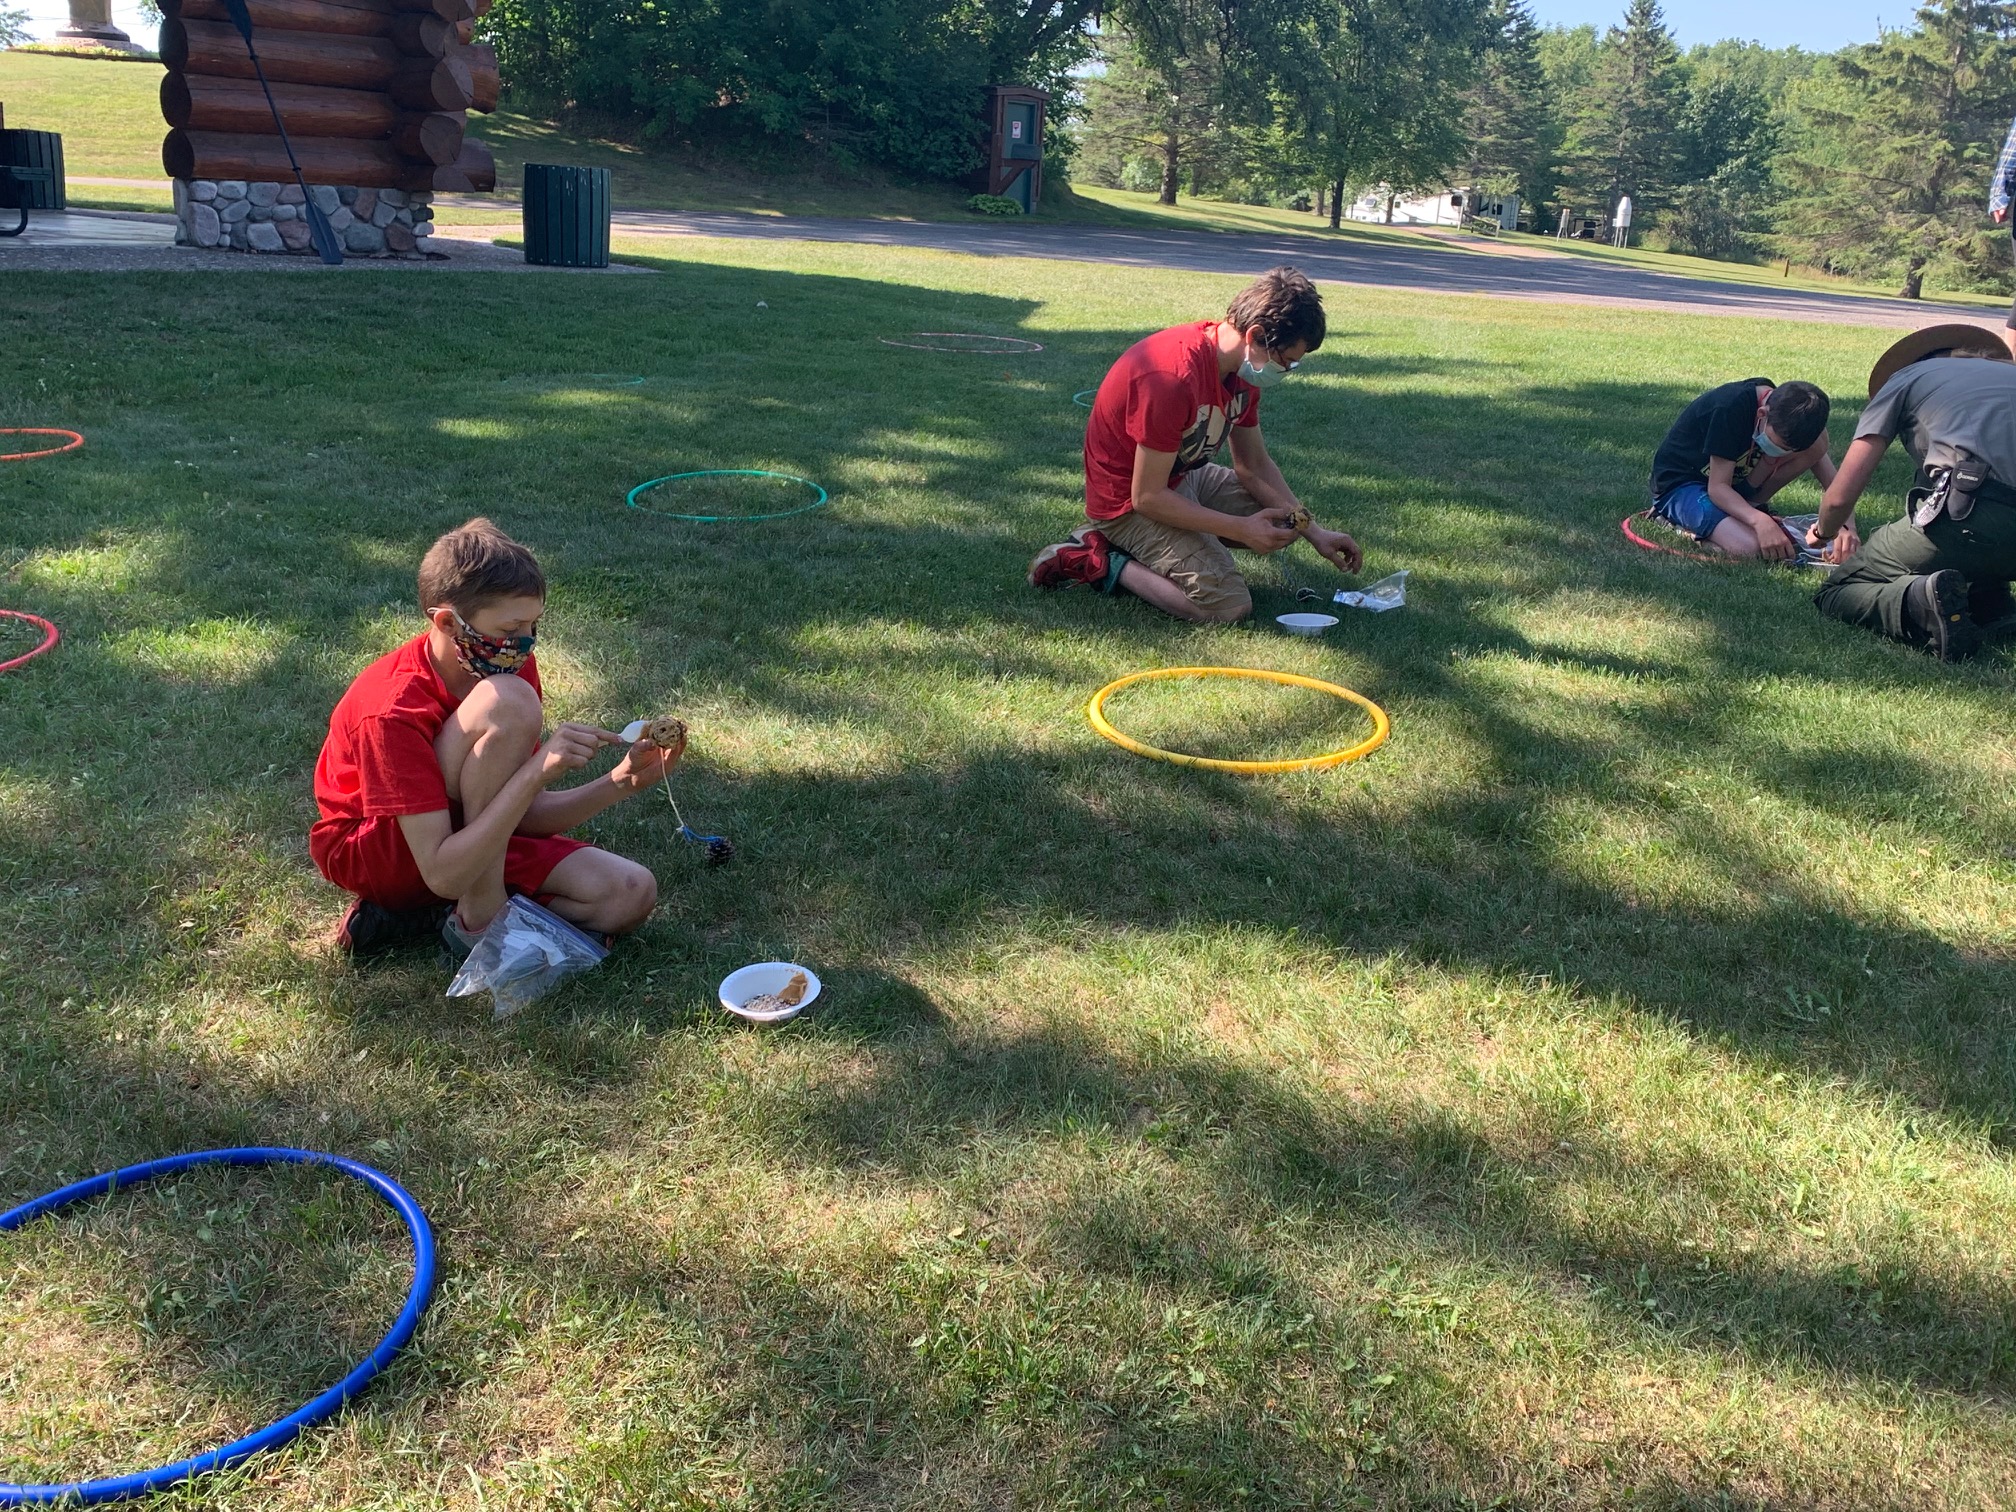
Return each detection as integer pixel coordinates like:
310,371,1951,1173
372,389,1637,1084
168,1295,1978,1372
159,0,500,256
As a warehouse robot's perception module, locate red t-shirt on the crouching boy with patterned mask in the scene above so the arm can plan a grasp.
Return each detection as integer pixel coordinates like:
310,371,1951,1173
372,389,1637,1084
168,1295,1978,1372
314,633,544,821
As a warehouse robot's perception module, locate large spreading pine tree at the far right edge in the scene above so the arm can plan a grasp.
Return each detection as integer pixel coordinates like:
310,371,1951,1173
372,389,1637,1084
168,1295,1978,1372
1782,0,2016,298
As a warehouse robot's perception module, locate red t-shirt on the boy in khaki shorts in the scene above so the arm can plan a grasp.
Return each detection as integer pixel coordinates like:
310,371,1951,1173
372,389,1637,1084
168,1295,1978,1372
1085,321,1260,520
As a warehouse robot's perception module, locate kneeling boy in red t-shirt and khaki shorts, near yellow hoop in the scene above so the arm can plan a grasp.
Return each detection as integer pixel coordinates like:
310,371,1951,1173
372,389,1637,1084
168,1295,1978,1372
1028,268,1363,621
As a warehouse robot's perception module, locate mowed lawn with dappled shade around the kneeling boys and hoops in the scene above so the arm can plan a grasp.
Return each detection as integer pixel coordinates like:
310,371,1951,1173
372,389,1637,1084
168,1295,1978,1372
0,240,2016,1510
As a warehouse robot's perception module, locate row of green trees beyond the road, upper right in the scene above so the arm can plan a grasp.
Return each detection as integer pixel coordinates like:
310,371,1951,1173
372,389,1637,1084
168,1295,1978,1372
1073,0,2016,298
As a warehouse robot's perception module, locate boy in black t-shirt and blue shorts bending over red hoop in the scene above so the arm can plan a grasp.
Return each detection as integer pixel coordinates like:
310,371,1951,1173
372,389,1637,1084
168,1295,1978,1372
1651,379,1855,562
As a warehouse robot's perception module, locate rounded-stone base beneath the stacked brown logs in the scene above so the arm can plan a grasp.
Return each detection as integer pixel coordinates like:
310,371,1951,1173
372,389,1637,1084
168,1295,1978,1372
175,179,433,258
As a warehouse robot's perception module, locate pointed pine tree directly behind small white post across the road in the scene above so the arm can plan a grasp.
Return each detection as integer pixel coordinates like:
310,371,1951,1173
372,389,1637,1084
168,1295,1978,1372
1568,0,1683,210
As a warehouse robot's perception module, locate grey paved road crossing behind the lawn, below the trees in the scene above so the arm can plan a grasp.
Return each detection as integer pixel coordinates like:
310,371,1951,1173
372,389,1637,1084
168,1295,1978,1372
613,210,2002,331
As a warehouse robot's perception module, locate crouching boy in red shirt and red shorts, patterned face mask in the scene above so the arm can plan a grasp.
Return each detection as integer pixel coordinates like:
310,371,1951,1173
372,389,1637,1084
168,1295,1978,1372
308,520,677,960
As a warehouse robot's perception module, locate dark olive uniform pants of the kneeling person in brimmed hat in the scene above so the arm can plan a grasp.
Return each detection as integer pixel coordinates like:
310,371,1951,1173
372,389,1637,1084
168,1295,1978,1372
1812,498,2016,643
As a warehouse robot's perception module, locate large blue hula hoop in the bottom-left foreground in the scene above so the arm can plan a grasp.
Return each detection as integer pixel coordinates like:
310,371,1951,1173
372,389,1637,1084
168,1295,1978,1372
0,1145,433,1506
